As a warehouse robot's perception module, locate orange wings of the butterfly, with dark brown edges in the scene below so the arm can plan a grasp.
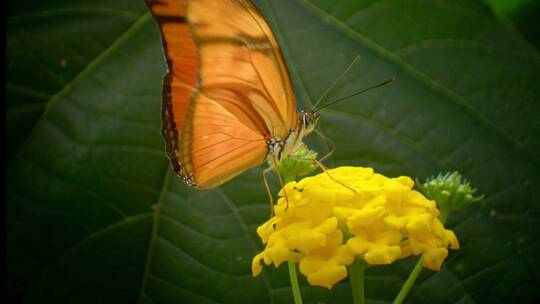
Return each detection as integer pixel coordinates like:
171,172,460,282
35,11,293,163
147,0,296,188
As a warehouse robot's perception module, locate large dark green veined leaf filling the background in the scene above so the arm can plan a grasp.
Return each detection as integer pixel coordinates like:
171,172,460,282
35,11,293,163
7,0,540,303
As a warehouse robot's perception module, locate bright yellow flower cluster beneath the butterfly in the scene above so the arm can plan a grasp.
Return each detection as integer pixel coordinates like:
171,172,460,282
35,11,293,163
252,167,459,288
